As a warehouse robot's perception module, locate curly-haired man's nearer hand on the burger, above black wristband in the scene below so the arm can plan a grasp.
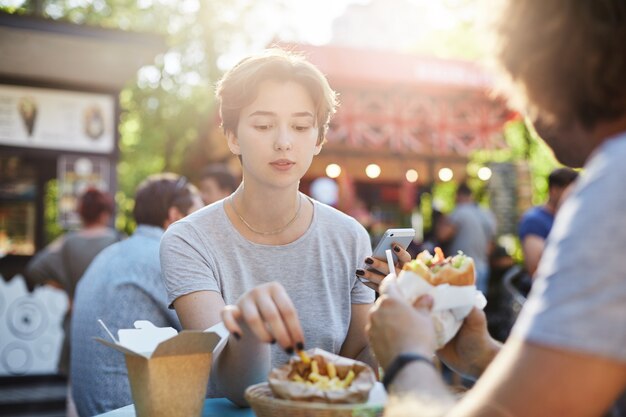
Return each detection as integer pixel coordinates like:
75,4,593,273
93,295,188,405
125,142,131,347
366,278,436,369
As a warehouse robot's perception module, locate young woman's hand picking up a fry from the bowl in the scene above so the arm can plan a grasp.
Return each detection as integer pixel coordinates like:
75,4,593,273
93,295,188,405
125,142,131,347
222,282,304,354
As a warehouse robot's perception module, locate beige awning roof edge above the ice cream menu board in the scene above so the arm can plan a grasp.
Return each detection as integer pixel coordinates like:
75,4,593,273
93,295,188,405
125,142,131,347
0,13,165,91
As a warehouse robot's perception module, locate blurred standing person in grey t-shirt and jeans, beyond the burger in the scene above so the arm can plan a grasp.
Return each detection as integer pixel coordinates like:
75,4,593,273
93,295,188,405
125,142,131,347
435,183,496,295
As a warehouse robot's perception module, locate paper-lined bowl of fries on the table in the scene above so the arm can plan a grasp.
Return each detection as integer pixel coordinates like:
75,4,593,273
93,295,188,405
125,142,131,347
246,349,382,417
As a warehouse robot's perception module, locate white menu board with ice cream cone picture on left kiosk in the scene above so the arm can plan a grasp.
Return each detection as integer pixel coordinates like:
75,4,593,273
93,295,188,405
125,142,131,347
0,84,116,154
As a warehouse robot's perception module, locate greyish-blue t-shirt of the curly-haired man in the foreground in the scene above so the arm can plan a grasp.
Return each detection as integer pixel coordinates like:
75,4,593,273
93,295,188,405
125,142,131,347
513,134,626,416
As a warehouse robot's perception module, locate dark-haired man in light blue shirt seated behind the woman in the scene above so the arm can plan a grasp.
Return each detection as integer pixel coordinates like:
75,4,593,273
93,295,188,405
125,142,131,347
70,174,203,416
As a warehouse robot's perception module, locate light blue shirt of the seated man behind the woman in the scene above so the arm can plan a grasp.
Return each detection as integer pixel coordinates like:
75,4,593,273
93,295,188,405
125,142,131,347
70,225,180,416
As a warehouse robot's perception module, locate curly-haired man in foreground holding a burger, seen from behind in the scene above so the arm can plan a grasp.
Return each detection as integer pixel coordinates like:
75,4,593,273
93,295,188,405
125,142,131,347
368,0,626,417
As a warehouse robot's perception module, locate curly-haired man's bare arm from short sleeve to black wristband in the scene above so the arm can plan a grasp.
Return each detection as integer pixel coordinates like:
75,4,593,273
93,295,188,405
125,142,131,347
388,334,626,417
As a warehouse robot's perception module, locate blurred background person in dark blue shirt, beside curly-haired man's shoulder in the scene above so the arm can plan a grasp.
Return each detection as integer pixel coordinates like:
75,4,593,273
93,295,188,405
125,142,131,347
518,167,578,277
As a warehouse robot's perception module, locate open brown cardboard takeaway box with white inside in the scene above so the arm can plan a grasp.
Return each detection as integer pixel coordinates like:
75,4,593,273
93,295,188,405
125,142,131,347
96,320,222,417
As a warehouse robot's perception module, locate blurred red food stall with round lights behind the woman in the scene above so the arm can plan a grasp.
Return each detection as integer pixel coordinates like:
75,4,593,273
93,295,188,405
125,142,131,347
285,44,514,229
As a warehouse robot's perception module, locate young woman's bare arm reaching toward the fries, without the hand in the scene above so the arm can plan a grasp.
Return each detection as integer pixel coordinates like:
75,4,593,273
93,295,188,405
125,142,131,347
174,291,271,406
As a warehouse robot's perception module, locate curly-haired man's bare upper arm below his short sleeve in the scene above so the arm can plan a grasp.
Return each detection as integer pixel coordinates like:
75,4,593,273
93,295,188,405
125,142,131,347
449,338,626,417
